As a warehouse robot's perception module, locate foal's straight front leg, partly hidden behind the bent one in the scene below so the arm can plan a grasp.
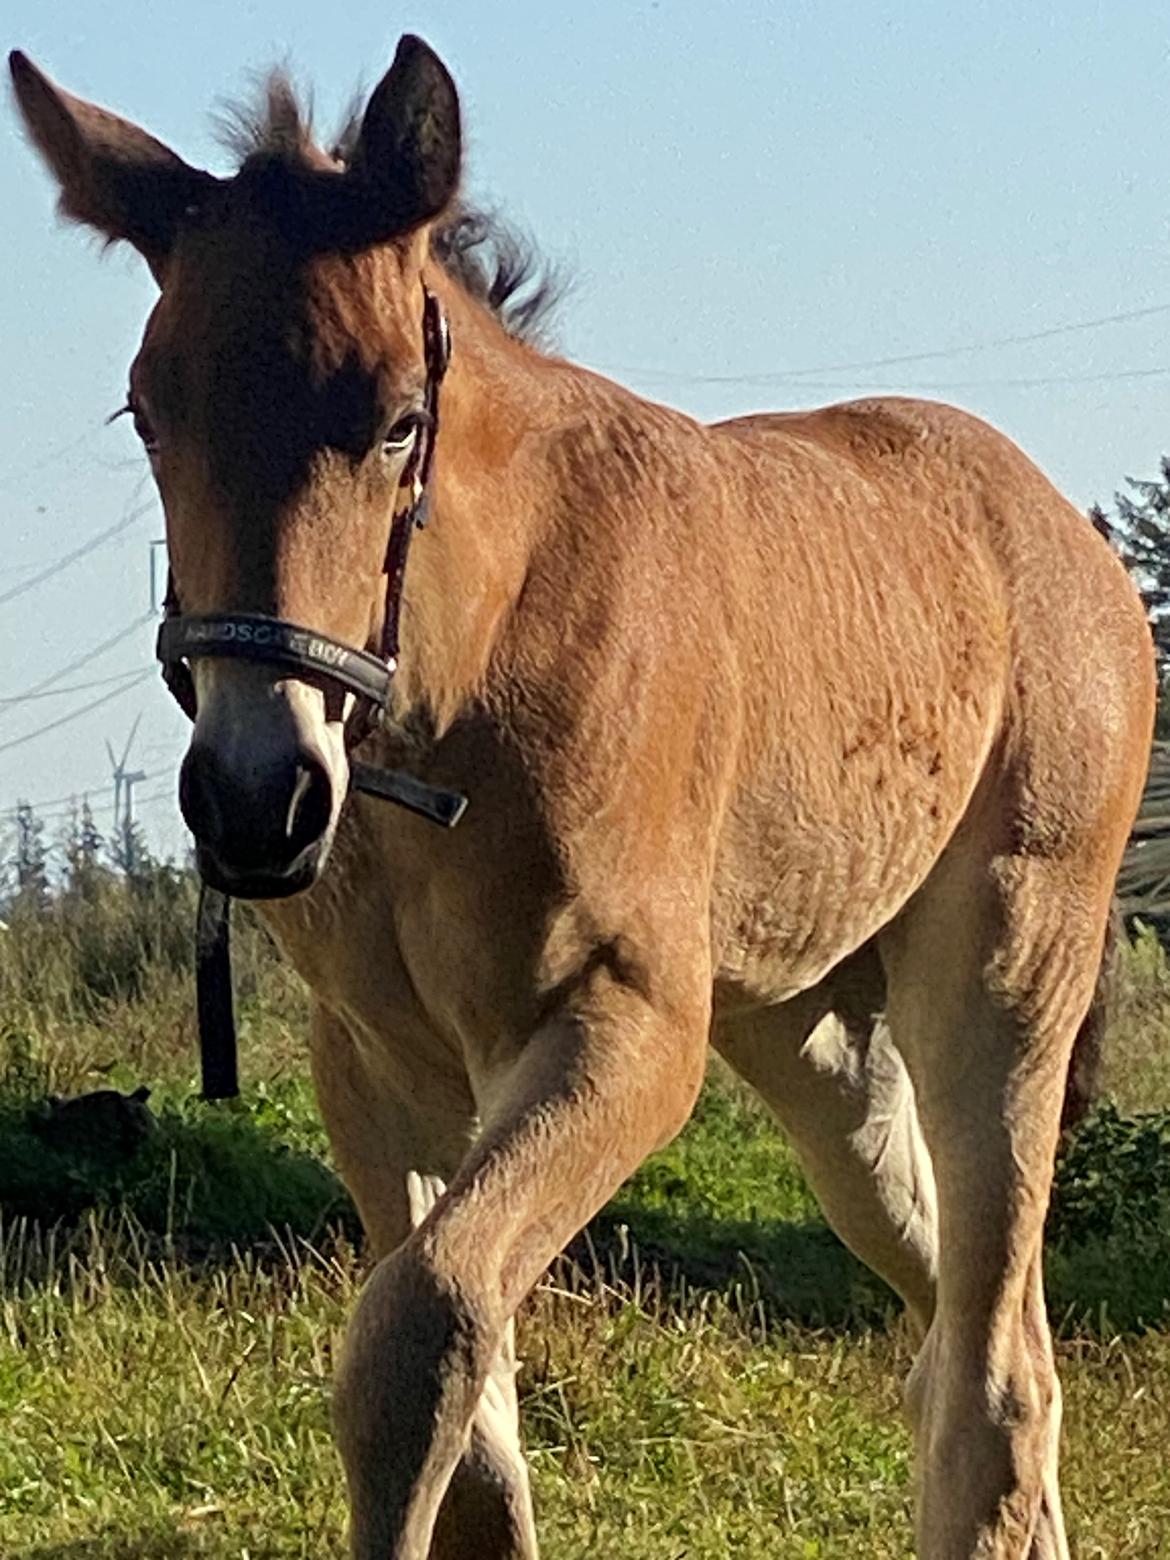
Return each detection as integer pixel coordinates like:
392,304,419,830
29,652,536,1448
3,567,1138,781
312,1008,537,1560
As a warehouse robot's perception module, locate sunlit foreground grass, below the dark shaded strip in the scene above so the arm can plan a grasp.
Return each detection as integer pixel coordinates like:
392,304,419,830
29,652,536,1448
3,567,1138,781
0,1223,1170,1560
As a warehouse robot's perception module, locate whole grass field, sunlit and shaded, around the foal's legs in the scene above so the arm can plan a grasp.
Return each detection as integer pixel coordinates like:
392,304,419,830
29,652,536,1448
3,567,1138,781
0,886,1170,1560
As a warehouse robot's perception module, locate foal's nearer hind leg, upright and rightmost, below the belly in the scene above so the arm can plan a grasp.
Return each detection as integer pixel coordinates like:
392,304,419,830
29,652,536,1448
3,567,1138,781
881,838,1109,1560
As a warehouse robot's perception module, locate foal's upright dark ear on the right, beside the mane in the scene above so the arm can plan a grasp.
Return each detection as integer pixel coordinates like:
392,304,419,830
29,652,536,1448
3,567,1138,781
348,33,460,243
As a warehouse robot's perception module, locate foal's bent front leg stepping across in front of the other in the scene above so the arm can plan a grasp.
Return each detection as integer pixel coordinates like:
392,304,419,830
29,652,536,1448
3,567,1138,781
335,948,710,1560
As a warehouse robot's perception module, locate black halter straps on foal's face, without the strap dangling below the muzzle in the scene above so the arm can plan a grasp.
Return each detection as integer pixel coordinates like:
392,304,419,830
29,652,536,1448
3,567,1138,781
154,289,466,827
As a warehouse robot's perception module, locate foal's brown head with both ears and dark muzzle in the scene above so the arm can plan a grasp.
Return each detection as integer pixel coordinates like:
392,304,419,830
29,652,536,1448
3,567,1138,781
11,37,460,897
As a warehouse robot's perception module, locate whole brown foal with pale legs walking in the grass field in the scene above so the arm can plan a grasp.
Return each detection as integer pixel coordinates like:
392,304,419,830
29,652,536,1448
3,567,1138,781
12,39,1153,1560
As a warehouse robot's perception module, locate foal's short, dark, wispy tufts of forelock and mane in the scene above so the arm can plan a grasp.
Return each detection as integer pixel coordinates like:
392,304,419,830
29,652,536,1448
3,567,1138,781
215,70,568,345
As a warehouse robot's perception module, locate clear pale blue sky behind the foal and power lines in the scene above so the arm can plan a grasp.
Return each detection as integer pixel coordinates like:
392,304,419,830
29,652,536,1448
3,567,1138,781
0,0,1170,849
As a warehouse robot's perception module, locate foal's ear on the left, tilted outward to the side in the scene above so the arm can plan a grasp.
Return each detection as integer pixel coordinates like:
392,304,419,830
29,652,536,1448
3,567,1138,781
8,50,217,275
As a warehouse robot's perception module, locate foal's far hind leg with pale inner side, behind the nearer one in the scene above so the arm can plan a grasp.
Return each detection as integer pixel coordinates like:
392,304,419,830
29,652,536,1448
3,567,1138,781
713,953,938,1334
